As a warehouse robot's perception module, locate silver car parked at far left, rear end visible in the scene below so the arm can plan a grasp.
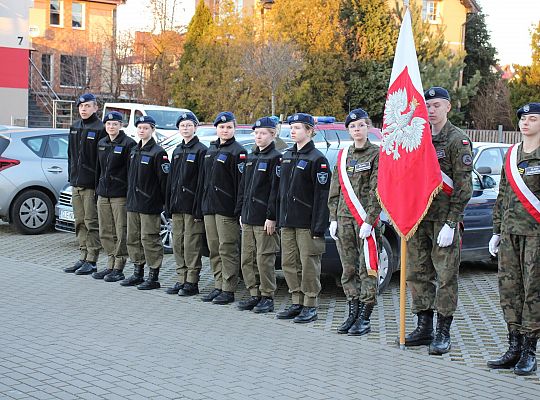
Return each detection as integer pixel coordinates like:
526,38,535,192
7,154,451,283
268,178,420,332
0,129,68,235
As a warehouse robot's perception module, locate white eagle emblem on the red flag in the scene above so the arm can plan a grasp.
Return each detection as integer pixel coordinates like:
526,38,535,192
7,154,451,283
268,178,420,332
381,89,426,160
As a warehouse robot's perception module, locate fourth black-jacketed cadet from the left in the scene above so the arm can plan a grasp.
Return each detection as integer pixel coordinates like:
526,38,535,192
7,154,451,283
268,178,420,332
165,112,208,296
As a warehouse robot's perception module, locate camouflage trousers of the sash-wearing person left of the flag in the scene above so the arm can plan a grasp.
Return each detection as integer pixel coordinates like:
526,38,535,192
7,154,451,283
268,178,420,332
336,217,380,303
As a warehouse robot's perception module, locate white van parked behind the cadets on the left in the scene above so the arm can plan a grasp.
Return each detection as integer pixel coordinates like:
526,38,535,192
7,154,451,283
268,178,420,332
103,103,189,142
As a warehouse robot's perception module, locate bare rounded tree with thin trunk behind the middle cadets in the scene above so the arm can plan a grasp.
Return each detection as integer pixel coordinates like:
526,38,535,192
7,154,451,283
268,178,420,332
242,40,303,115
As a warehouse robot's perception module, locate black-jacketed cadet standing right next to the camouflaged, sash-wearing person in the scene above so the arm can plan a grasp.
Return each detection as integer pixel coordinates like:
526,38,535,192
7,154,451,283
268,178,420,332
277,113,332,323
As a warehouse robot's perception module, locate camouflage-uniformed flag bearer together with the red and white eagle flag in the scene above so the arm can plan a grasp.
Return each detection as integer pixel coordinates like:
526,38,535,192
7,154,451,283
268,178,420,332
377,0,472,354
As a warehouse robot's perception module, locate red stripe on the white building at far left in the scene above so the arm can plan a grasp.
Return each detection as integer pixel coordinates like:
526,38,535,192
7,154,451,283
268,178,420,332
0,47,29,89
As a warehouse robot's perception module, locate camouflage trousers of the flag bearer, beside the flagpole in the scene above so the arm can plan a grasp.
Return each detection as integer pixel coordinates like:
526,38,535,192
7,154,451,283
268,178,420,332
407,221,461,317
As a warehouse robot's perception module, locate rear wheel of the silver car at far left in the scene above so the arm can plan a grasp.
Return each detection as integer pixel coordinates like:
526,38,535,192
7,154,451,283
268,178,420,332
11,190,54,235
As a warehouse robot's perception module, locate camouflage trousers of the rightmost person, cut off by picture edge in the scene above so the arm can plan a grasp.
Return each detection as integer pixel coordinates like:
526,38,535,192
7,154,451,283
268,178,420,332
499,234,540,337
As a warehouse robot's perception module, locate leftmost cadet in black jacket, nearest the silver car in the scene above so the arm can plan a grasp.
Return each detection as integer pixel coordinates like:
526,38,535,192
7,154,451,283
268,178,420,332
64,93,107,275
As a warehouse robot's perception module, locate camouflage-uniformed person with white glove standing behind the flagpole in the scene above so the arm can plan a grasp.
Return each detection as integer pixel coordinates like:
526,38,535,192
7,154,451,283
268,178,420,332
405,87,473,355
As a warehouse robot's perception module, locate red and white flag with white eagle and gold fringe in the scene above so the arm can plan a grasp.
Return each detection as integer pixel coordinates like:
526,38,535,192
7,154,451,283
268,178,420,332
377,8,442,239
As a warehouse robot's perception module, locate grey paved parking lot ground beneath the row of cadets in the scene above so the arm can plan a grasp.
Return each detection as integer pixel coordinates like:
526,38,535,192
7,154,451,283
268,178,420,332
0,224,540,399
